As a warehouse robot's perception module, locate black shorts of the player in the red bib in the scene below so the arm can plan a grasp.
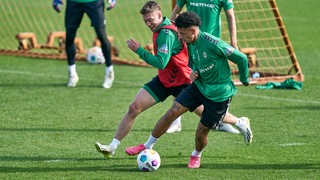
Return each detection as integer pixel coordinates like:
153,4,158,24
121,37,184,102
143,76,190,103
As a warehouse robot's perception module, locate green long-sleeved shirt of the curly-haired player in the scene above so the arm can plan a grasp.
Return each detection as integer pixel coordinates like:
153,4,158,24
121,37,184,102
188,32,249,102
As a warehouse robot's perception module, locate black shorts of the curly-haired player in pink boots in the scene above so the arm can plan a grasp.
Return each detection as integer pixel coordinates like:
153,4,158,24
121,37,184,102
176,83,231,129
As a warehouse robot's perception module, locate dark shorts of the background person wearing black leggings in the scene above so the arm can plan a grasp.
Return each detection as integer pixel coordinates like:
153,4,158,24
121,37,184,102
65,0,106,28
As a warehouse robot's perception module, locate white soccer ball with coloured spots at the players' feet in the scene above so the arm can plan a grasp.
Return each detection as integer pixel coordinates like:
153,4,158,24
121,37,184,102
137,149,161,172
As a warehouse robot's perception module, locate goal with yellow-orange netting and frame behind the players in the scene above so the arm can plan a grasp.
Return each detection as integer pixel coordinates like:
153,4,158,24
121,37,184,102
0,0,304,85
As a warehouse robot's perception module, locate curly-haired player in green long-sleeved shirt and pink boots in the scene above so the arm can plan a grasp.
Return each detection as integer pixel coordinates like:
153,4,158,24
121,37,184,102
125,12,253,168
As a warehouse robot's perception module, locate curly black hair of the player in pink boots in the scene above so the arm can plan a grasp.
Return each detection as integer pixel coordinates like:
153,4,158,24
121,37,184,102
175,11,201,28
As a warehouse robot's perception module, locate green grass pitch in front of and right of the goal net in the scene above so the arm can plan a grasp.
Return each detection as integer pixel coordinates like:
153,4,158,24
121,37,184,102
0,0,320,179
